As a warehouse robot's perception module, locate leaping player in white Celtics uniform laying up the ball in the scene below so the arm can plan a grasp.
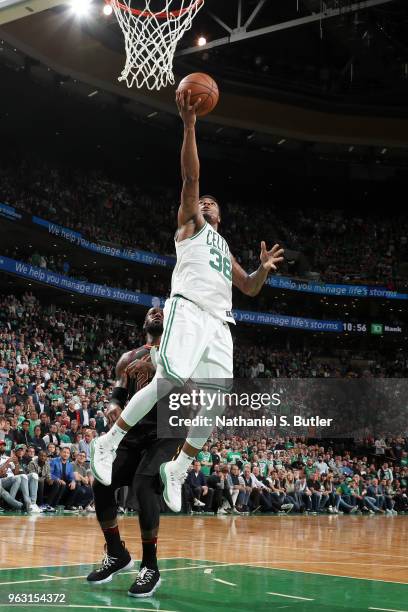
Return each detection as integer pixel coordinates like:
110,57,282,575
91,92,283,512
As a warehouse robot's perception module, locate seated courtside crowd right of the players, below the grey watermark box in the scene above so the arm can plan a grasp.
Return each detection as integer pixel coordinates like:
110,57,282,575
184,437,408,515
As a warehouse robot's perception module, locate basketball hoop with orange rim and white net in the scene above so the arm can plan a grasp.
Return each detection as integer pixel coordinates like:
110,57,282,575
106,0,204,89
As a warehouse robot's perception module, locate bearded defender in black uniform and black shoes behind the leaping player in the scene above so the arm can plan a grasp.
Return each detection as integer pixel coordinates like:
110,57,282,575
87,308,182,597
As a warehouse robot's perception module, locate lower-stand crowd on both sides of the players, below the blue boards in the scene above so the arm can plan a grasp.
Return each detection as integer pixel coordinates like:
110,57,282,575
0,293,408,514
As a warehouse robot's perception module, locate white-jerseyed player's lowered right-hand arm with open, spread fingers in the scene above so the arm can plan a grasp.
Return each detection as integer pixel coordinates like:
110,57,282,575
231,241,284,297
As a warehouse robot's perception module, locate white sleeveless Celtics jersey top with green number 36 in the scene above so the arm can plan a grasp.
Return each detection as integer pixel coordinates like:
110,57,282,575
171,223,235,323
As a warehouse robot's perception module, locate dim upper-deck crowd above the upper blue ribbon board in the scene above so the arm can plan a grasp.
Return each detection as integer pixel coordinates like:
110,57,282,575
0,162,408,288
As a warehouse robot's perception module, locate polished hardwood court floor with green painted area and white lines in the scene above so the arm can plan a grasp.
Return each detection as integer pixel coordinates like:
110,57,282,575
0,515,408,612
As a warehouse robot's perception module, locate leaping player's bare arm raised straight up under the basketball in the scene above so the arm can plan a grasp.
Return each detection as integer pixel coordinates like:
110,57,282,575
176,90,205,232
